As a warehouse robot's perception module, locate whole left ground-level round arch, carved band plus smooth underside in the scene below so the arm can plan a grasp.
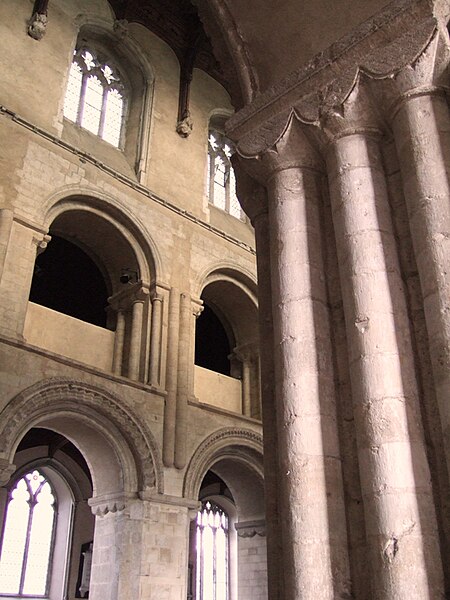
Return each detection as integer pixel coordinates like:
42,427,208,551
0,378,163,500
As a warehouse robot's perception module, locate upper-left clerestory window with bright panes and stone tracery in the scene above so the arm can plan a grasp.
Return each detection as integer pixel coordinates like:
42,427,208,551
64,47,125,148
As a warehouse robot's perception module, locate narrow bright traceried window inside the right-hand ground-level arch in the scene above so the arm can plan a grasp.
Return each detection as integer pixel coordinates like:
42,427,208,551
195,500,229,600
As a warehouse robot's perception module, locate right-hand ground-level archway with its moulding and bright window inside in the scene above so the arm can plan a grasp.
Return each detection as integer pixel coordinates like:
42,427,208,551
185,432,267,600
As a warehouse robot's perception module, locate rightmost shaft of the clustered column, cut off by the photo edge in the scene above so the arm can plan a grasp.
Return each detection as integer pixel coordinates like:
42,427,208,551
393,93,450,474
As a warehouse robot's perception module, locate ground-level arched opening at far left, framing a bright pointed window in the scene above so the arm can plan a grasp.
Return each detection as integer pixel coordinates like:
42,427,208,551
0,427,94,600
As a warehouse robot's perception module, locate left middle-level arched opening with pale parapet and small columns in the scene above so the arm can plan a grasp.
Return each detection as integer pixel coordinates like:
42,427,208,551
24,203,151,379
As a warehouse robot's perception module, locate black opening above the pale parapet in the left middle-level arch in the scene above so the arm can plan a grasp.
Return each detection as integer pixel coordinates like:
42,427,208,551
30,235,108,327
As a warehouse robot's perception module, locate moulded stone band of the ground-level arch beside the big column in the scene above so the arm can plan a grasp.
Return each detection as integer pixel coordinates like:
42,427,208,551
183,427,263,498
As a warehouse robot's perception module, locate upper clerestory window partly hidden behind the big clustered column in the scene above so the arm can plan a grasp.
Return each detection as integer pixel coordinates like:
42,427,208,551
207,130,244,220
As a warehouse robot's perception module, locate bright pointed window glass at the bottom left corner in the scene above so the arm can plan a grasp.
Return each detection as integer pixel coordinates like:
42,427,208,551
0,470,56,598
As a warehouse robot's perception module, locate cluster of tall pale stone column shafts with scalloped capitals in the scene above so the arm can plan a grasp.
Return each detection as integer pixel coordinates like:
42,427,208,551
235,40,450,600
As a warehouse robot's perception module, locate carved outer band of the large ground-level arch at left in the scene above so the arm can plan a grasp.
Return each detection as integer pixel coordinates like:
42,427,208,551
0,378,163,492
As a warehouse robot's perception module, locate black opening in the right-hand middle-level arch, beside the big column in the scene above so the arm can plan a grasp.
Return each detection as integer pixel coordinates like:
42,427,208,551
195,304,231,375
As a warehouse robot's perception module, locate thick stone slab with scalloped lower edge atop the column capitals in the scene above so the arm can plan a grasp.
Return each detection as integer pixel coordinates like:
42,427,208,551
227,0,438,157
